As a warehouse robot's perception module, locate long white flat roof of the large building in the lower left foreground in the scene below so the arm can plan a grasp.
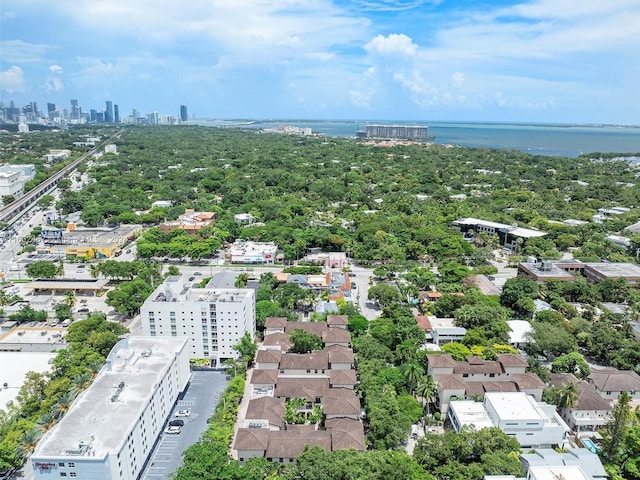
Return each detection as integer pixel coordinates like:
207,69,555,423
33,337,187,458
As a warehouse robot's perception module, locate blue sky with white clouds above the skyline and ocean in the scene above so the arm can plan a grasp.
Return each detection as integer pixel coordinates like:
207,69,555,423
0,0,640,125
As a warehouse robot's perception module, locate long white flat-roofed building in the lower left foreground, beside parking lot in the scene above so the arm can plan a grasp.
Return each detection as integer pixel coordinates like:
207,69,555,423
31,337,190,480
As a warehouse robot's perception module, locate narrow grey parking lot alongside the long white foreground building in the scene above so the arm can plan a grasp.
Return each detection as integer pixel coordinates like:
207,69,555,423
142,370,227,480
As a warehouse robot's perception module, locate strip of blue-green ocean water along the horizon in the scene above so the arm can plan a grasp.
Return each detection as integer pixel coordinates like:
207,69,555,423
189,119,640,158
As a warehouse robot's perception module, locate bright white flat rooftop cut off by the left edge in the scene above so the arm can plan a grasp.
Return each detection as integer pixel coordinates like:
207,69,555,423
0,352,56,411
